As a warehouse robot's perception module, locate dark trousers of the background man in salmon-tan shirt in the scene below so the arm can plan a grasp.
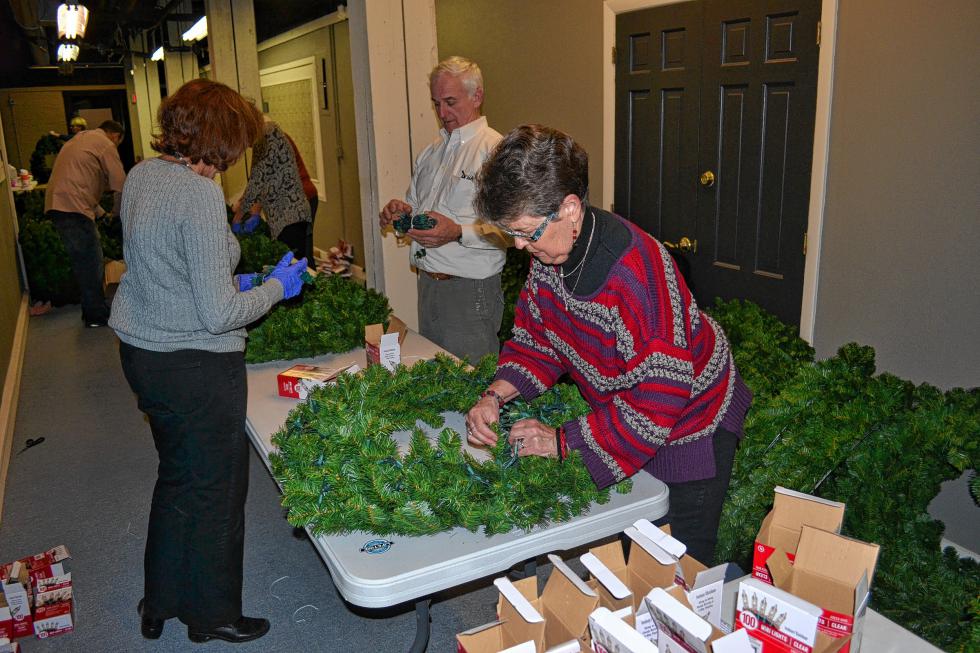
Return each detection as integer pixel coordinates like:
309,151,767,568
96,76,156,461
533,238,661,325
45,211,109,322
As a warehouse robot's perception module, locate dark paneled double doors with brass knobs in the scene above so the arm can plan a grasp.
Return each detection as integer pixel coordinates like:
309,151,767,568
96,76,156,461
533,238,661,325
615,0,820,324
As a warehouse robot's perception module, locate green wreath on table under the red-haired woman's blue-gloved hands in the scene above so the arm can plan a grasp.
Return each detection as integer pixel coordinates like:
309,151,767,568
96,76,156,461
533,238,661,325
245,270,391,363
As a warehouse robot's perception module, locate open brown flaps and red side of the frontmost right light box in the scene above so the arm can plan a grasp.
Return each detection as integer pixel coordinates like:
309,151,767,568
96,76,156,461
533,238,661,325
769,526,880,653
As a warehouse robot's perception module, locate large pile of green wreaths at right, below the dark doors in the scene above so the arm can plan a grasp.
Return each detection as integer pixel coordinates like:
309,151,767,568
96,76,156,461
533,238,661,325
713,302,980,651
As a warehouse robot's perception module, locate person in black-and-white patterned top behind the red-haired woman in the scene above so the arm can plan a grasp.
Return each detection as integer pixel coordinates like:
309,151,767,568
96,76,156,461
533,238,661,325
235,118,313,265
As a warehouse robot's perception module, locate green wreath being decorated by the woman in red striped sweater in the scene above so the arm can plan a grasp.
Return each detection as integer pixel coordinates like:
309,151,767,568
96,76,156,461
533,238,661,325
269,355,632,536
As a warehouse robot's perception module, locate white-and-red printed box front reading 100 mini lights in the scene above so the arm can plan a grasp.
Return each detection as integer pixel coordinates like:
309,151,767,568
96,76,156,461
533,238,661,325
735,578,821,653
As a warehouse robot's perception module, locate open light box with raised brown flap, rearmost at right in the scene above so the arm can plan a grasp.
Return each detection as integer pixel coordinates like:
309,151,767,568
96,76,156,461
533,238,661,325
752,486,844,584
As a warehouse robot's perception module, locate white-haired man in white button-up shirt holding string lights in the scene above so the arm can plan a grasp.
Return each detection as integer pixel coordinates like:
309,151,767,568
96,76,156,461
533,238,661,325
379,57,509,362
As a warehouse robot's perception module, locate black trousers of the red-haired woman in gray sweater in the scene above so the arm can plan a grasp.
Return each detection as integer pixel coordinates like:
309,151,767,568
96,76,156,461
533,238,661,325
119,343,249,628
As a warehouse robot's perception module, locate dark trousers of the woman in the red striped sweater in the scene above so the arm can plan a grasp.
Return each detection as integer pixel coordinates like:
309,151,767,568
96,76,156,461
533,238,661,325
657,429,738,567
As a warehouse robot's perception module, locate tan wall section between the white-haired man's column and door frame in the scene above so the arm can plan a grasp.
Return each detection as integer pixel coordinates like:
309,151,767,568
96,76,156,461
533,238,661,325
436,0,605,206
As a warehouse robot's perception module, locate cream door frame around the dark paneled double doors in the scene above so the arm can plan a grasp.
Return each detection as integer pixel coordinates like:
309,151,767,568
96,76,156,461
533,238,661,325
602,0,840,344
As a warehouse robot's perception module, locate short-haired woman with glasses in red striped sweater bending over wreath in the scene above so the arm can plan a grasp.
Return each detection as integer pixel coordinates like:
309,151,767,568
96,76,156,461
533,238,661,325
467,125,752,563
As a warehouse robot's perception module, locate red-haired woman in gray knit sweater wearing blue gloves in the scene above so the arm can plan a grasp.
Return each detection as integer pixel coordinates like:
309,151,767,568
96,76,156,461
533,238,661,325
109,79,306,642
